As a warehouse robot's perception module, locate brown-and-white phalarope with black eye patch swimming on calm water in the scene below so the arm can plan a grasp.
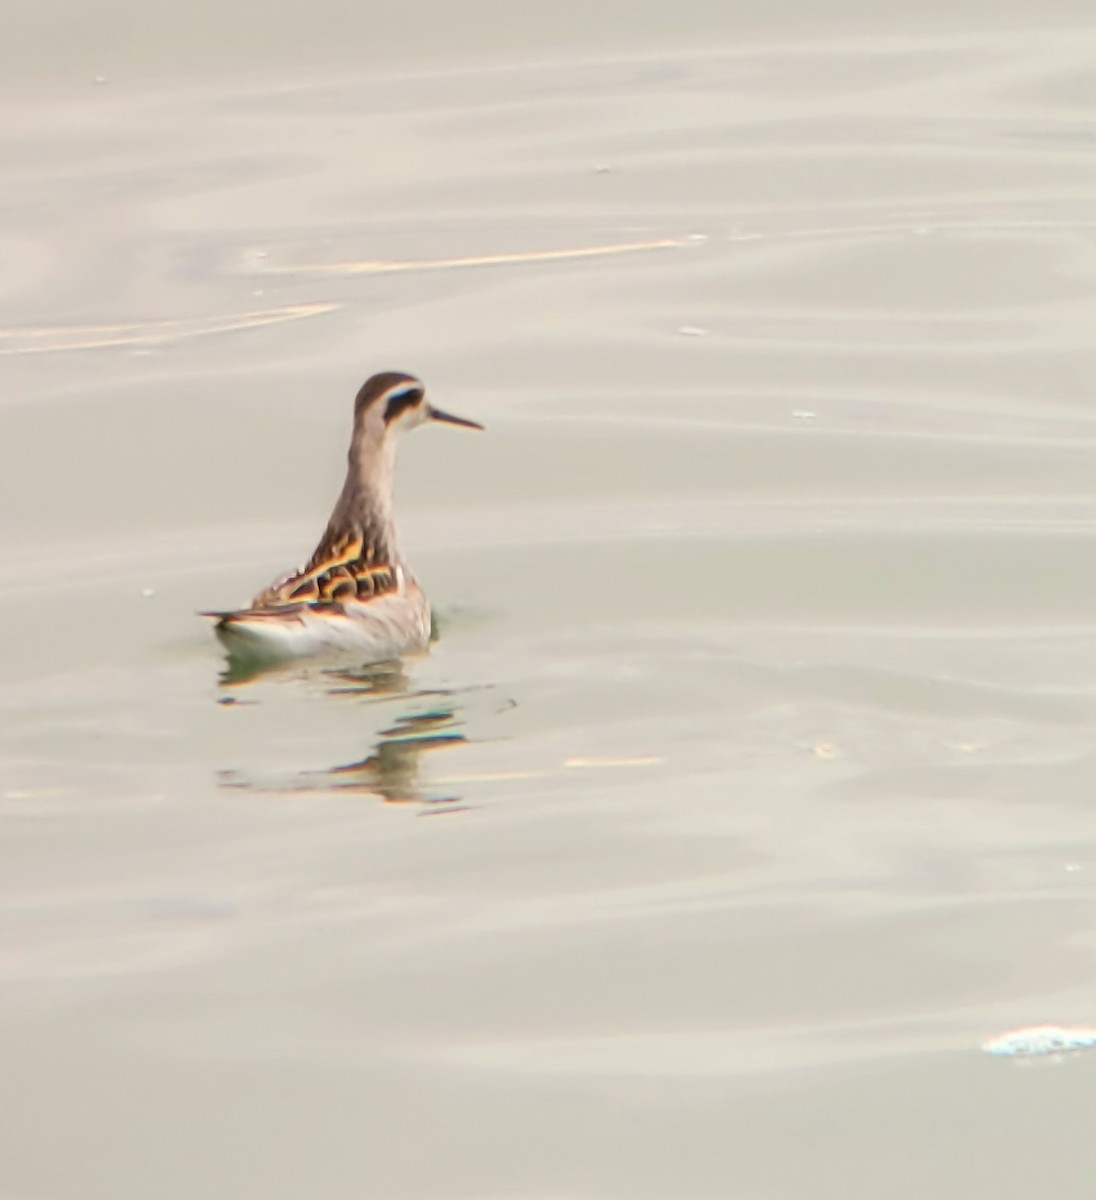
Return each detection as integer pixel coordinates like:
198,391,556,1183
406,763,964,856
202,371,483,664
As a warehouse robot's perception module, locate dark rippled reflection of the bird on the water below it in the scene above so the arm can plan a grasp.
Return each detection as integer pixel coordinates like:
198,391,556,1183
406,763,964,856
218,662,467,809
